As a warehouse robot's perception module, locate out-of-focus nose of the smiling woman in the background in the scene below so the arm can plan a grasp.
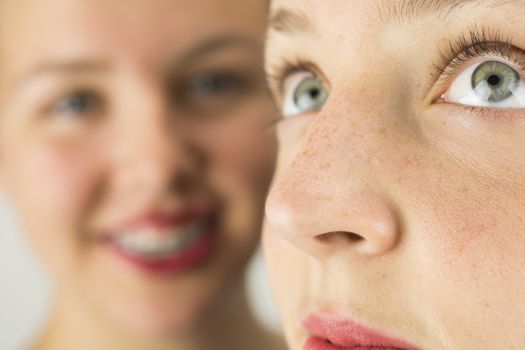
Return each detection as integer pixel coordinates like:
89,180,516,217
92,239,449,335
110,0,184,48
109,89,203,198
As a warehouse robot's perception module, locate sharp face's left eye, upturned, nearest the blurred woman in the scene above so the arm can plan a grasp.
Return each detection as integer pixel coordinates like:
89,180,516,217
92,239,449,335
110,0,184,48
282,72,329,117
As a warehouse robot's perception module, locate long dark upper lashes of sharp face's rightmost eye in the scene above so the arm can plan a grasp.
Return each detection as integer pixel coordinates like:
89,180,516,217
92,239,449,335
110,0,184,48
433,27,525,80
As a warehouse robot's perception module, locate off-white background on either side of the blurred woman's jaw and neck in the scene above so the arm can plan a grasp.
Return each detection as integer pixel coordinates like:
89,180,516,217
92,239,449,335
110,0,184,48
0,194,279,350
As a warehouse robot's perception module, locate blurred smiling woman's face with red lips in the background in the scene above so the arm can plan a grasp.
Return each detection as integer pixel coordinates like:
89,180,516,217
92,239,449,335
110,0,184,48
0,0,275,333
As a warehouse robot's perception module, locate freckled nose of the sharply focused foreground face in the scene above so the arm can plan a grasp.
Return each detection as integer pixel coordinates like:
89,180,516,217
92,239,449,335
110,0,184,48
266,103,401,259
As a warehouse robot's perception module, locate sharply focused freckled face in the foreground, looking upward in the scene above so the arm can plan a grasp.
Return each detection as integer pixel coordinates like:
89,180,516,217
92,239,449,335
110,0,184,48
264,0,525,350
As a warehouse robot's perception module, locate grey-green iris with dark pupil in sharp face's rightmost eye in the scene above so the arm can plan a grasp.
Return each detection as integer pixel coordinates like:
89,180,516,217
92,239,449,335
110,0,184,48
472,61,520,102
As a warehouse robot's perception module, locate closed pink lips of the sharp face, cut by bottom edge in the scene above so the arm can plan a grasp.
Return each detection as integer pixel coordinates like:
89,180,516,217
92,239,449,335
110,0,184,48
303,314,417,350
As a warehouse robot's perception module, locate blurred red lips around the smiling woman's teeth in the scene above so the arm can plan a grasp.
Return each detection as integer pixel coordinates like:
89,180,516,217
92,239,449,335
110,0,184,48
103,208,217,274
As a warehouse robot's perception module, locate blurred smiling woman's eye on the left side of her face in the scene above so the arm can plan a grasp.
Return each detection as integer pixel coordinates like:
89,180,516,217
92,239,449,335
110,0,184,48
52,91,102,117
